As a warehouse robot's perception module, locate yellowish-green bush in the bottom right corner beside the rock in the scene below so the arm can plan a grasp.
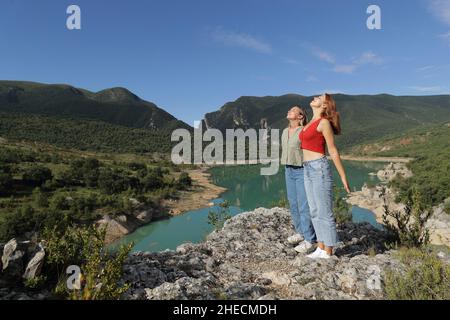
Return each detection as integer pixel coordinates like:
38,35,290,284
385,248,450,300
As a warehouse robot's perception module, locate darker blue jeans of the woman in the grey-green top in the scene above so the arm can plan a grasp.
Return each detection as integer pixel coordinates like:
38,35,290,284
284,166,317,243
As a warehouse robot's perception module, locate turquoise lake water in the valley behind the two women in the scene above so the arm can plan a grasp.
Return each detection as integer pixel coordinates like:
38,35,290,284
112,161,384,251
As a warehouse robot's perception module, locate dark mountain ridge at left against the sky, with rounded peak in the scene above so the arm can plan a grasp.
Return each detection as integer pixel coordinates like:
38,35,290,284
0,80,191,130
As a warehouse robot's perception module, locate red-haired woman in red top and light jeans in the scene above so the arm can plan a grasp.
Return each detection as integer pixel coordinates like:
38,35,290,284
299,94,350,259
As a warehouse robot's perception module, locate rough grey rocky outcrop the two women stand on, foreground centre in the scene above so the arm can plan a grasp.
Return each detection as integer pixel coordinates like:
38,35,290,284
124,208,414,299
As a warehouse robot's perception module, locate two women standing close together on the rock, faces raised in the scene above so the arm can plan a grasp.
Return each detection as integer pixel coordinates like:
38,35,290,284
281,94,350,259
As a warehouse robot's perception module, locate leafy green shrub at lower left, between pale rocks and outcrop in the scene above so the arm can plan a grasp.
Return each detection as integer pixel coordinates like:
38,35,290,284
44,226,132,300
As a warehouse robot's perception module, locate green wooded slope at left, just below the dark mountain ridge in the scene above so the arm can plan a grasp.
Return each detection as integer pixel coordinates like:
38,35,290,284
0,112,181,153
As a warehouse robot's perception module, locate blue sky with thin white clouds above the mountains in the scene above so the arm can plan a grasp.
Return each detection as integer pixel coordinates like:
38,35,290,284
0,0,450,125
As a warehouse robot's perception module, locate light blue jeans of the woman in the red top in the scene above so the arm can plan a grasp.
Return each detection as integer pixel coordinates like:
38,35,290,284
303,156,339,247
